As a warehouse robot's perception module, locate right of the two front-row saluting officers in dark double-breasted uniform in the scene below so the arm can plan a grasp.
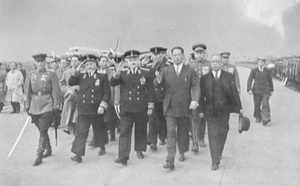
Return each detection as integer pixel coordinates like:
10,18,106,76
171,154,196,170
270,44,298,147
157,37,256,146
110,50,155,165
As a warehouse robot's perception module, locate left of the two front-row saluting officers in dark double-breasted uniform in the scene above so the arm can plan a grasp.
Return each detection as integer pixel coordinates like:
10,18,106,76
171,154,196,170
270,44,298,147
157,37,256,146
69,55,110,163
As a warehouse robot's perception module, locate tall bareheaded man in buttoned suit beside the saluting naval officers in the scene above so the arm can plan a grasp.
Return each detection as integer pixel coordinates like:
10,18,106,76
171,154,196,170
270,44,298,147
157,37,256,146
154,47,200,170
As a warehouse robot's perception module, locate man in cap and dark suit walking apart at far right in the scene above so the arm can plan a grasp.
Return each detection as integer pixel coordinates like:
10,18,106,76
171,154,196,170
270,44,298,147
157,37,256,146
247,58,274,125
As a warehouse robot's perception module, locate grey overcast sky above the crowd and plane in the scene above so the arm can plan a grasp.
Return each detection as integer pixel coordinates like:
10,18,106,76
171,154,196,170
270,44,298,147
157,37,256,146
0,0,300,61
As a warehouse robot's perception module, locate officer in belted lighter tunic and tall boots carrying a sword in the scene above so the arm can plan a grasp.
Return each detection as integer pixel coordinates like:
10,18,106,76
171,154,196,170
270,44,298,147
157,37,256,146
26,54,61,166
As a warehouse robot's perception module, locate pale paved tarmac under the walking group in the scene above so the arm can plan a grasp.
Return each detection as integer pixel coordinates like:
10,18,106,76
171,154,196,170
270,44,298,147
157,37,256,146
0,67,300,186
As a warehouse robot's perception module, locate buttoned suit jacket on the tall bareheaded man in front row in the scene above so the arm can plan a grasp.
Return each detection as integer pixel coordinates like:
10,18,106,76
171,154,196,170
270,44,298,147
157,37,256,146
154,65,200,117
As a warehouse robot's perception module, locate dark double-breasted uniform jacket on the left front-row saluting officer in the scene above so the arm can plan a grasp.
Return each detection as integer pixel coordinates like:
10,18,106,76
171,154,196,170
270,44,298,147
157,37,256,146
69,70,110,115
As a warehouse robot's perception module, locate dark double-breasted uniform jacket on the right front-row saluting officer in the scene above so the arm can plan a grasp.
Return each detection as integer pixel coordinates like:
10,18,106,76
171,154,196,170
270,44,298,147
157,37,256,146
110,68,155,113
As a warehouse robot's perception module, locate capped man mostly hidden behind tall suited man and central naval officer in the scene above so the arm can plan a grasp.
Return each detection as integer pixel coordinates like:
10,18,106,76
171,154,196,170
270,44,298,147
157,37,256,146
147,47,170,150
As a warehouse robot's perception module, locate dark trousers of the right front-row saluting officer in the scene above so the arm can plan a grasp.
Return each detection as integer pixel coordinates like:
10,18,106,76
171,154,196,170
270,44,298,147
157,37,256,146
119,112,148,159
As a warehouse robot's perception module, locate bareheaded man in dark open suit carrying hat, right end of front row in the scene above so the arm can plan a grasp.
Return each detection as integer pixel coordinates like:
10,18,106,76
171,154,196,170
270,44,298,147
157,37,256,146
199,54,242,170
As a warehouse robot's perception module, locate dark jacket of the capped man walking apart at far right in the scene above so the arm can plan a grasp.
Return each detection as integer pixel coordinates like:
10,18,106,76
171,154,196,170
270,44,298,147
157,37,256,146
247,67,274,94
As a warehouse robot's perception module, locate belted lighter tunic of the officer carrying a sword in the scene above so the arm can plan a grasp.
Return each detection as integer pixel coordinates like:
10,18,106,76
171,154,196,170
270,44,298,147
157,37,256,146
26,69,61,115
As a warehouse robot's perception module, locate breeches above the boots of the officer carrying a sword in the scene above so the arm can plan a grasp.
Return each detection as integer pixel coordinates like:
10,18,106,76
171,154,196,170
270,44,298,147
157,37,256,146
31,112,54,139
